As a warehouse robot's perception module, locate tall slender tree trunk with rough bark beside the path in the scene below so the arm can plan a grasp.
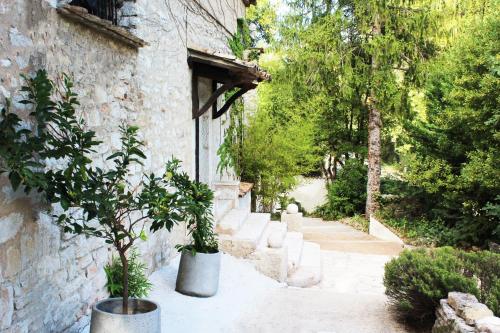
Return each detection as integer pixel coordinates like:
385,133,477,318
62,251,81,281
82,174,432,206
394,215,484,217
365,14,382,219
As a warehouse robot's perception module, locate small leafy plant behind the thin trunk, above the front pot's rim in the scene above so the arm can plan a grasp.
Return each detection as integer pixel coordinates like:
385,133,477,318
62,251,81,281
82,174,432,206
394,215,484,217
104,248,153,298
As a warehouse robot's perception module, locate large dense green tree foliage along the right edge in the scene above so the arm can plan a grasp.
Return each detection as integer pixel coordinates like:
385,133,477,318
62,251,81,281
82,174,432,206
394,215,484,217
390,15,500,246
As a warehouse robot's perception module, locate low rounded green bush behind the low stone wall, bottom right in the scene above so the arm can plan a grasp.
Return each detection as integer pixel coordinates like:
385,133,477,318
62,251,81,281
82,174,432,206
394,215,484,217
384,247,500,323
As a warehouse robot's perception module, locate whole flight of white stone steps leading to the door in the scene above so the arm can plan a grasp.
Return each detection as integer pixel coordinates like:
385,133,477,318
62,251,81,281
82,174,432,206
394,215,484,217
214,183,322,288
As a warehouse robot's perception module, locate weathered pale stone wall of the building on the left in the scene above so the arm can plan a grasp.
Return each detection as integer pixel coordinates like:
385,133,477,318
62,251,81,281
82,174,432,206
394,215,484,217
0,0,244,333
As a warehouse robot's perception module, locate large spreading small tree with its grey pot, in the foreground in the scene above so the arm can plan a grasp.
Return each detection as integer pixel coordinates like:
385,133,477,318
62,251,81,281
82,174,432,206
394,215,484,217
0,71,188,333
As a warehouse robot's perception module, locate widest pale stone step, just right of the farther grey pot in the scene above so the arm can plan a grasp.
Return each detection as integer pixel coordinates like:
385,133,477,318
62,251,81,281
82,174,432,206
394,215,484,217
219,213,271,257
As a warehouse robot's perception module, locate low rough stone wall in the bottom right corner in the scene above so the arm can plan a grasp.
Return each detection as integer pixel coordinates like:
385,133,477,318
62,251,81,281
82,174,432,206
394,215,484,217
432,292,500,333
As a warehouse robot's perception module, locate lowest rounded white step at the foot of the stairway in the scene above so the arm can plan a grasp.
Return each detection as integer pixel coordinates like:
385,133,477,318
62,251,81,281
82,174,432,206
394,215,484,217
287,242,323,288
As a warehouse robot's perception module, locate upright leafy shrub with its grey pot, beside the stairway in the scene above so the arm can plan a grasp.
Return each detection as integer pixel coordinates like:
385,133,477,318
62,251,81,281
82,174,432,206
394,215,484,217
171,166,221,297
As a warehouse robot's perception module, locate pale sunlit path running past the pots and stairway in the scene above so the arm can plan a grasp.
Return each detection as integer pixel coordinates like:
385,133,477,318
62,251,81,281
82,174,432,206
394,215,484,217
151,219,409,333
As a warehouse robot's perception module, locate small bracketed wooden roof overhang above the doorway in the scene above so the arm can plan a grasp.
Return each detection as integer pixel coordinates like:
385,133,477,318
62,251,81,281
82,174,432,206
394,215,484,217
188,48,271,118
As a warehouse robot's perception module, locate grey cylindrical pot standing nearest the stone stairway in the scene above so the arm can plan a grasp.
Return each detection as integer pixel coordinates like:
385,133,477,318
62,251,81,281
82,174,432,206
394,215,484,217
175,251,220,297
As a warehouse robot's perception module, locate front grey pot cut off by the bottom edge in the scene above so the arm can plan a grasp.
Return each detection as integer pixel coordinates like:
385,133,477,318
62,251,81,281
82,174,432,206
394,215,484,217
90,298,161,333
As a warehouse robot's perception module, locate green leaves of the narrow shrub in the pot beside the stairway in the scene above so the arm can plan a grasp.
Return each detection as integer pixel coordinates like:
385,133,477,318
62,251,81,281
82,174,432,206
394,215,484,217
167,160,218,254
